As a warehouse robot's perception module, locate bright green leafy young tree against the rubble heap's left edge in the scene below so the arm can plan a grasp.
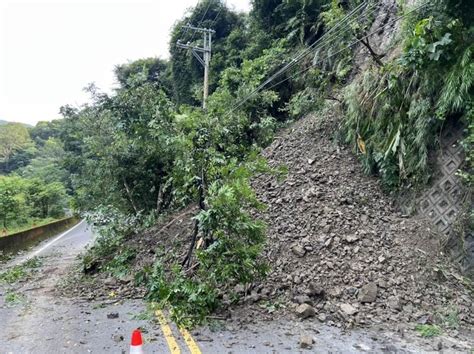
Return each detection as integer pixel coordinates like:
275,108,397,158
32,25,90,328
196,160,267,285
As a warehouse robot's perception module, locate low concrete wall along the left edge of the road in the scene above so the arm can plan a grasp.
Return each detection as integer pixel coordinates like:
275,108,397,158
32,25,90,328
0,216,79,254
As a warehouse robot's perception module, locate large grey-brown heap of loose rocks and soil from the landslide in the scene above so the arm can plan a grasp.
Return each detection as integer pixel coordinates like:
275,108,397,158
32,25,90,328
248,109,474,326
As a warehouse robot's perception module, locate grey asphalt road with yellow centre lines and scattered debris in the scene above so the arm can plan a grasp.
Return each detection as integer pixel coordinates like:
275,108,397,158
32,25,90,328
0,222,446,354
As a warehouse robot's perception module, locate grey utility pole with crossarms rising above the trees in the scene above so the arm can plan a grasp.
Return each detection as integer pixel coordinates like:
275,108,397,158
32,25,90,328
176,25,216,109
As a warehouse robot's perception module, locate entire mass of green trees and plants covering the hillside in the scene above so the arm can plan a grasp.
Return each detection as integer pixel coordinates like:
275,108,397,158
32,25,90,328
0,0,474,324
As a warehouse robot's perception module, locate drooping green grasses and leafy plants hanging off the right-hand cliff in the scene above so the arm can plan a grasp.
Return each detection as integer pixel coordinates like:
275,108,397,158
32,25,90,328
343,3,474,189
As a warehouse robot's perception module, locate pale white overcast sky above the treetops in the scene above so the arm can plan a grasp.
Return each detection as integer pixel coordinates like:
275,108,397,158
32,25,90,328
0,0,250,125
